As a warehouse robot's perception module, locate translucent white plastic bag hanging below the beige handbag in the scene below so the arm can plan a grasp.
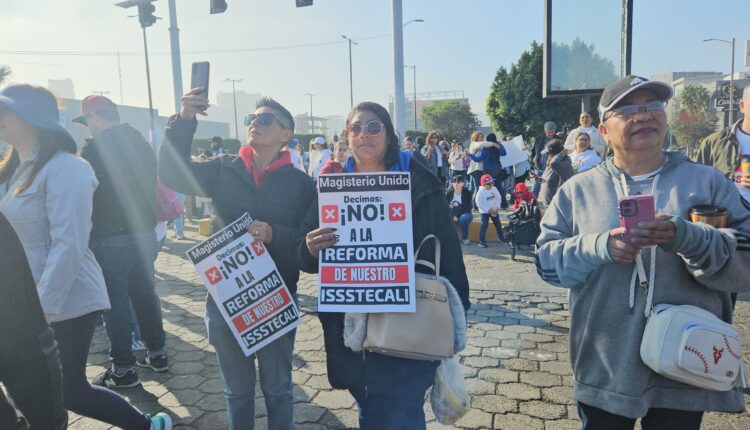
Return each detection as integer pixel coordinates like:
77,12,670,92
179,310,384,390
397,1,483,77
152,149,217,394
430,356,471,425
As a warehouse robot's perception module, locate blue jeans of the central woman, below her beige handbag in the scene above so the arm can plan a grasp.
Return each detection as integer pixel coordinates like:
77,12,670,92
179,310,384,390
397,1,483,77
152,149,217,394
350,352,440,430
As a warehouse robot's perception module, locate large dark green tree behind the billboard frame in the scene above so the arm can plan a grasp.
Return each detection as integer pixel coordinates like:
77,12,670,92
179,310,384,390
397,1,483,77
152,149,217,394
487,42,599,137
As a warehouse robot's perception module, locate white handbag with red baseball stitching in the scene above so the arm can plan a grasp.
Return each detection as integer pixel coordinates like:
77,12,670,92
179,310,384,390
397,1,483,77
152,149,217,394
641,302,744,391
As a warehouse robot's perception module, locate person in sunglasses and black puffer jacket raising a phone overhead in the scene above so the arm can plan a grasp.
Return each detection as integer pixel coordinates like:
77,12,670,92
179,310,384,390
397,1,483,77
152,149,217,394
159,88,315,429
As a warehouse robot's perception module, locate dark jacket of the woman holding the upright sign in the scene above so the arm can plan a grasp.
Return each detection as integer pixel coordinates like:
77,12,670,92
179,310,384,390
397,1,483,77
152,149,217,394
297,151,471,391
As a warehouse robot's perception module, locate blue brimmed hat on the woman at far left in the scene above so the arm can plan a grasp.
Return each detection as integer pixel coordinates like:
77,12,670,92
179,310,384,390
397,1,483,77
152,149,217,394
0,85,74,141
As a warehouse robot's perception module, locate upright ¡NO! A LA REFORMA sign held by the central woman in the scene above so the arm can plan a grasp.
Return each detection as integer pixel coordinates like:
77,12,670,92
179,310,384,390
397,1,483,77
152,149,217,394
318,172,416,313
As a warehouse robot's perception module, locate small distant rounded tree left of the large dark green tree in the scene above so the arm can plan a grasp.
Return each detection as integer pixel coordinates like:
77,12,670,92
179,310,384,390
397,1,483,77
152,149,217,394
421,100,481,140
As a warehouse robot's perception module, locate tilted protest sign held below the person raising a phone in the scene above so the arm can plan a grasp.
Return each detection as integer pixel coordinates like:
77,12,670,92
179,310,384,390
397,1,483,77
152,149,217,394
187,213,300,356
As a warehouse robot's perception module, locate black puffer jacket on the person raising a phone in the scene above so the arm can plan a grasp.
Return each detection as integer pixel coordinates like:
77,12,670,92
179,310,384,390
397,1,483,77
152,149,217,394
159,116,315,292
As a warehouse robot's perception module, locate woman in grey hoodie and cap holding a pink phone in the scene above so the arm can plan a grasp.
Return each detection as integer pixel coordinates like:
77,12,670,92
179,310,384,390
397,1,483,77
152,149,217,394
536,75,750,430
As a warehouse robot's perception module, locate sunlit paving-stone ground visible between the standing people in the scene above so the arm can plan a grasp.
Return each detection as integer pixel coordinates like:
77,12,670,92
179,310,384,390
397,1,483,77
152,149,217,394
70,223,750,430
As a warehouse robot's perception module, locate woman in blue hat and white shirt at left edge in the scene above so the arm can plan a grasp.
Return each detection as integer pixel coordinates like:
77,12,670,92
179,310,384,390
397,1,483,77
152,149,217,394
0,84,172,430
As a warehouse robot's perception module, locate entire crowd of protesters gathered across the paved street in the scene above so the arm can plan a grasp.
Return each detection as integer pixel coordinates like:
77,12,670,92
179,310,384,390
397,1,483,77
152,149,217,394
0,72,750,430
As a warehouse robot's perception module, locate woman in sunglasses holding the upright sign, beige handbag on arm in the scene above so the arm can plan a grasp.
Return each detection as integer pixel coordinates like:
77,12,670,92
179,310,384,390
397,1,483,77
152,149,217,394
297,102,469,430
